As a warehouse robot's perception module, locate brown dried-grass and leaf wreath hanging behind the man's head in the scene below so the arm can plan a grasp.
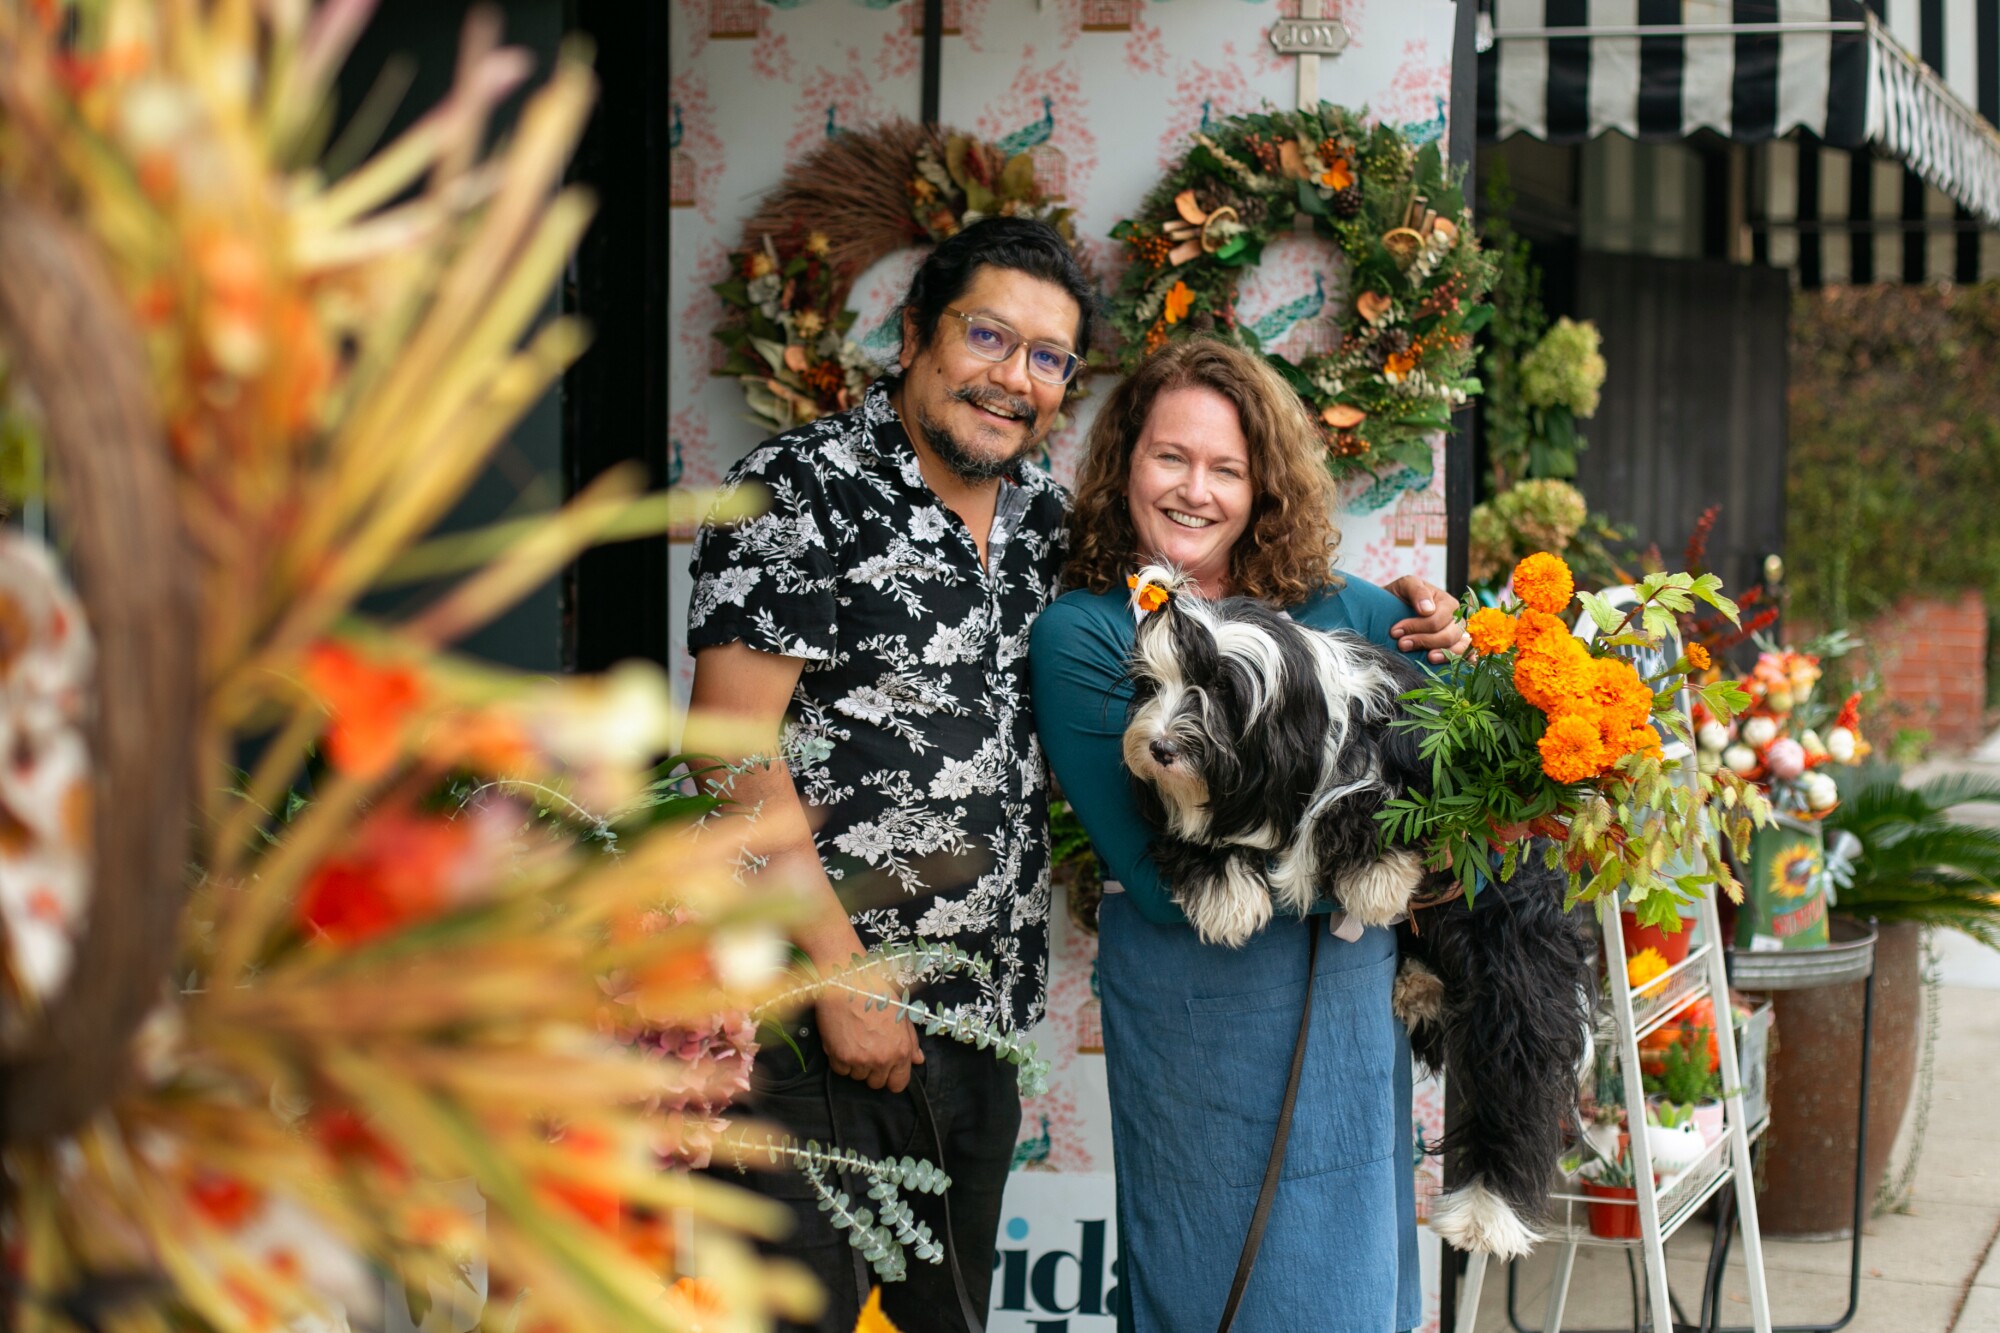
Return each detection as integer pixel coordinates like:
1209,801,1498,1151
714,120,1076,430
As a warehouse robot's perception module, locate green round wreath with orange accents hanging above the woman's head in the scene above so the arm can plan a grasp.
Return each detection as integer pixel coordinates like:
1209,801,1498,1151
1110,102,1492,474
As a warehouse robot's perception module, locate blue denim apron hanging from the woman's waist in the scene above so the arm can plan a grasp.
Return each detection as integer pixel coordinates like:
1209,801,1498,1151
1098,893,1422,1333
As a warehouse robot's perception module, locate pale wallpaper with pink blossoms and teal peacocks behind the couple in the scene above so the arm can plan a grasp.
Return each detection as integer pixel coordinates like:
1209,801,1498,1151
668,0,1454,1331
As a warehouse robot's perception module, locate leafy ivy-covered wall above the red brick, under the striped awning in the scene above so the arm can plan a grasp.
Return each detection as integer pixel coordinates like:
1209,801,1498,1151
1786,282,2000,652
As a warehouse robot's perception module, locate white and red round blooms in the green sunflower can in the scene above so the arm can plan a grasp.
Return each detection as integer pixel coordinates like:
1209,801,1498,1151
1696,642,1872,819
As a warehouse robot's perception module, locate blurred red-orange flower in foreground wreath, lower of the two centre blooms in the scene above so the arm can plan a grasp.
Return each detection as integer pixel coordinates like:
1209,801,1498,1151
294,809,472,945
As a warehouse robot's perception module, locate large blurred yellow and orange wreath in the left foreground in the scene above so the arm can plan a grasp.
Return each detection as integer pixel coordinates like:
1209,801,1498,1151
0,0,900,1333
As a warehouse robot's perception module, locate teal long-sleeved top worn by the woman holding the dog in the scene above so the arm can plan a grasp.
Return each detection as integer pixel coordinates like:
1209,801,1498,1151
1028,574,1428,925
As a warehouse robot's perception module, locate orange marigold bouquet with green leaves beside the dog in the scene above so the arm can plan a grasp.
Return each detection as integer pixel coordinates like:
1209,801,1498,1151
1380,552,1768,927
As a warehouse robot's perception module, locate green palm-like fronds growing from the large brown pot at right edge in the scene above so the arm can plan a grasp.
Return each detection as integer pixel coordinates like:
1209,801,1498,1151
1828,777,2000,949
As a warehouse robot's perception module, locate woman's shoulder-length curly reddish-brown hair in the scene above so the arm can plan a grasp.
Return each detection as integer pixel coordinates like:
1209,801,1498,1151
1062,338,1340,606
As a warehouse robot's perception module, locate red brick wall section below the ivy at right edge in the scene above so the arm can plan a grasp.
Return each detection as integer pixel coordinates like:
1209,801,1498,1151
1862,590,1986,749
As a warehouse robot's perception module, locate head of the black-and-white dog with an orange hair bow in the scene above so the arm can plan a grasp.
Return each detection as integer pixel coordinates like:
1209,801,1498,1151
1124,590,1326,847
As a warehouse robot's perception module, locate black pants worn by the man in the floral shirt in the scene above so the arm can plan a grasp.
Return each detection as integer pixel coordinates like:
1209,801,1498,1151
726,1011,1020,1333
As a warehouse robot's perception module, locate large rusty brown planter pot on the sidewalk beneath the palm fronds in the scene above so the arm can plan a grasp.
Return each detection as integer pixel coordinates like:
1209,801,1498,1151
1758,923,1924,1241
